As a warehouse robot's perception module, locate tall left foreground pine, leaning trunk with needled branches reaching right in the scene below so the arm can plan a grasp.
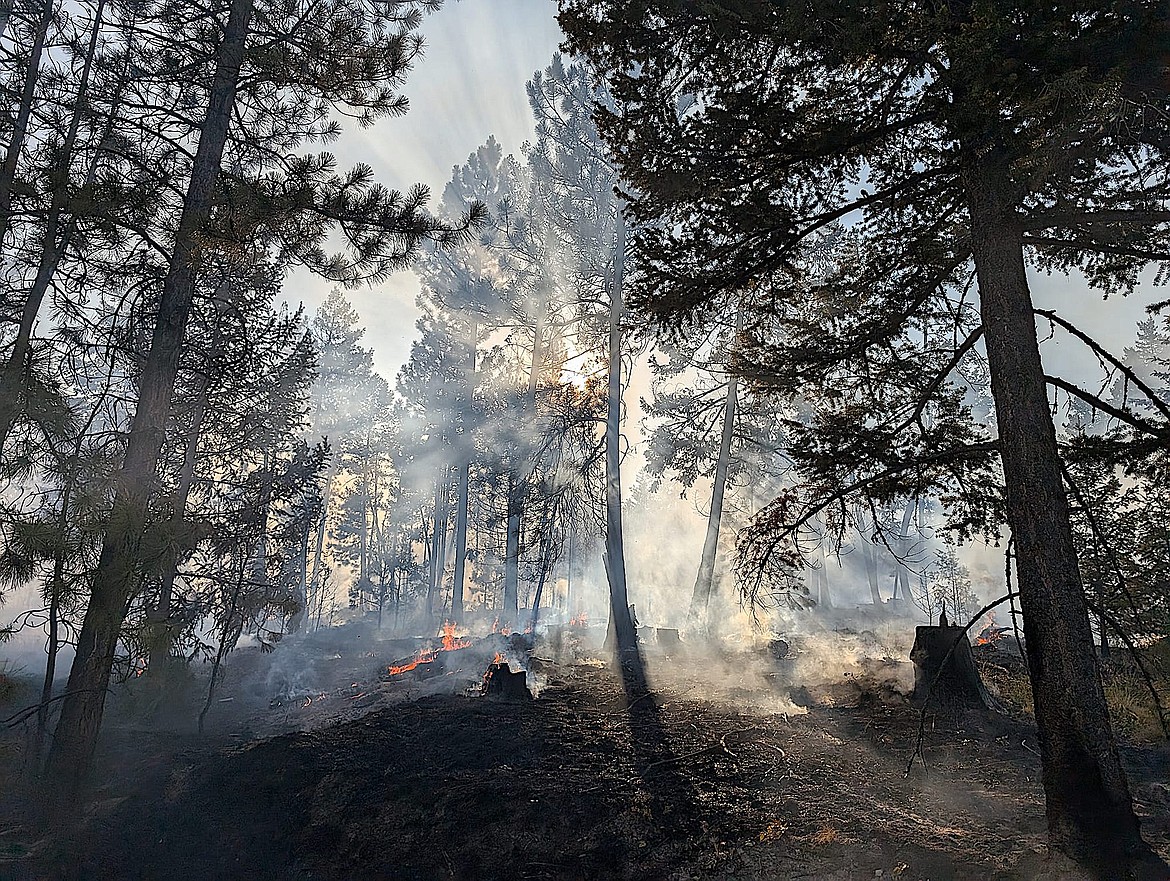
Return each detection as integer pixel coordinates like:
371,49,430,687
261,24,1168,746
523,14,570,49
43,0,477,810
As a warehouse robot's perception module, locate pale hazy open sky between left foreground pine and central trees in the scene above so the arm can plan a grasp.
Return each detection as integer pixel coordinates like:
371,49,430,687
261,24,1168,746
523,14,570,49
284,0,562,374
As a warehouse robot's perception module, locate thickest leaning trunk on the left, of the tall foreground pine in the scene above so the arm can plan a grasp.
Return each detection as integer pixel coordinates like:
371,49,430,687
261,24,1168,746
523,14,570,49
49,0,253,810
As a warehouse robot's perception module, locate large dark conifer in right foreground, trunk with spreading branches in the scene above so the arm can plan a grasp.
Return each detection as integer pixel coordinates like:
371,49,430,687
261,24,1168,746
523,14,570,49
560,0,1170,876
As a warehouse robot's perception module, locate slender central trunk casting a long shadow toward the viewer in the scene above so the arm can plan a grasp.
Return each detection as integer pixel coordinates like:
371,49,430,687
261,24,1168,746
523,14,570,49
605,209,638,655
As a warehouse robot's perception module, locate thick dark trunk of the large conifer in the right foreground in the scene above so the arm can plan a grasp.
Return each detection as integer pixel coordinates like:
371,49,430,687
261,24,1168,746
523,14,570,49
964,158,1147,877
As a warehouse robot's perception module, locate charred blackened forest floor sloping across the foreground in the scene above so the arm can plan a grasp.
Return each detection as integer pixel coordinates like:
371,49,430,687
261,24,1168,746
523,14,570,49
0,627,1170,881
